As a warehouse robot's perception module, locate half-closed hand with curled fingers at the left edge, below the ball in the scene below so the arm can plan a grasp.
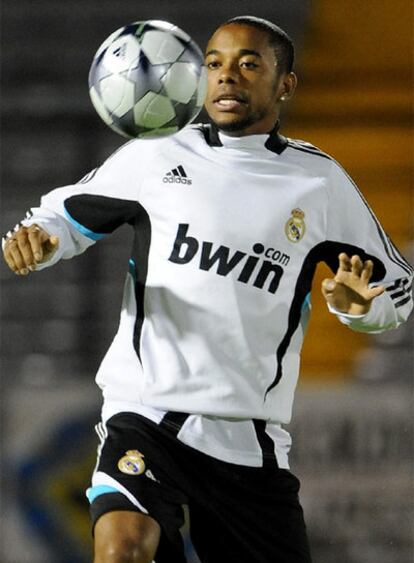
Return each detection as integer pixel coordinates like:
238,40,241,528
3,225,59,276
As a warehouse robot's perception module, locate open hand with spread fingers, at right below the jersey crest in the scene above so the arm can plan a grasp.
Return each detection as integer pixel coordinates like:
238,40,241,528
322,252,385,315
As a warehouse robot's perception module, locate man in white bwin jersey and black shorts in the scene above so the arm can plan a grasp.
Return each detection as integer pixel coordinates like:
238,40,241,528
4,17,412,563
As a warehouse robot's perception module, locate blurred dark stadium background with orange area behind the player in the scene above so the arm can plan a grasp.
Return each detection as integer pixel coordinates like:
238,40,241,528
0,0,414,563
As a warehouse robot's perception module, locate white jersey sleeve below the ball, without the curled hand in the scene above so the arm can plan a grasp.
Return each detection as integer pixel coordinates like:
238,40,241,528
22,141,149,270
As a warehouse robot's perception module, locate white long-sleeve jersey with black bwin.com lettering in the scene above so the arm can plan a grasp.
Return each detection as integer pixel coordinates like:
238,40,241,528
21,125,412,467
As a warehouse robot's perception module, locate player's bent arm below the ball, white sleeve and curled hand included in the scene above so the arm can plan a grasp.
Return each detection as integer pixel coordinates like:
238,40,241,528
3,139,146,275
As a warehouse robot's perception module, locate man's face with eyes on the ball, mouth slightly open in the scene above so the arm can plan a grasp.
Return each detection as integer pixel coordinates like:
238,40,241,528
205,24,283,136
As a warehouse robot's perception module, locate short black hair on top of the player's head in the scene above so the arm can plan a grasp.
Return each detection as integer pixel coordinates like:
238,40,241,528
220,16,295,72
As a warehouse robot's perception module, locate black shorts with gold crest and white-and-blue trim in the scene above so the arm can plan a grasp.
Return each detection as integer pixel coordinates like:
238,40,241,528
88,413,311,563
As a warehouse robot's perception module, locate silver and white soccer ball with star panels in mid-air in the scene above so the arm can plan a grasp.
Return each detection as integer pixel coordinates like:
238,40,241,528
89,20,207,138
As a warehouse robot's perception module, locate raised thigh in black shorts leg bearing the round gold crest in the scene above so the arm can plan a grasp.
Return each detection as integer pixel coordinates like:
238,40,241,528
87,413,186,563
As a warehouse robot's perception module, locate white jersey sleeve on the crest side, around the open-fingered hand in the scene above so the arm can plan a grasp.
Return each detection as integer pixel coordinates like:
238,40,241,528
326,163,413,333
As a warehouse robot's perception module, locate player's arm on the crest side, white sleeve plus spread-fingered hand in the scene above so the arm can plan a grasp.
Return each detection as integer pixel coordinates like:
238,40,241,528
322,164,413,332
